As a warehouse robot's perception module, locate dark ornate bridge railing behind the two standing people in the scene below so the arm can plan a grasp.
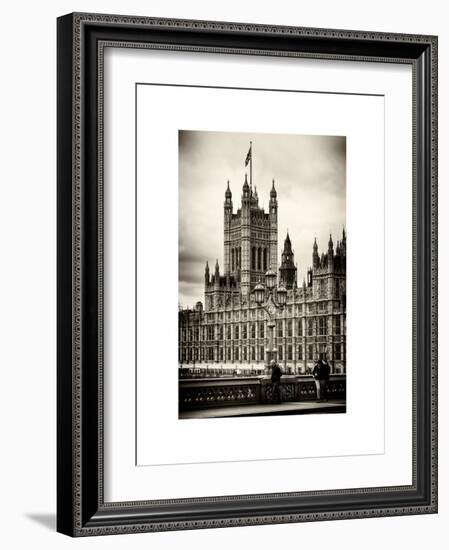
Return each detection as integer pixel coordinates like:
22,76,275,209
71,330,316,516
179,374,346,411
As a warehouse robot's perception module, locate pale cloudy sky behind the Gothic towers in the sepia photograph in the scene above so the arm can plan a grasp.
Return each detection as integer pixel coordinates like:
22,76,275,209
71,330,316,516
179,131,346,307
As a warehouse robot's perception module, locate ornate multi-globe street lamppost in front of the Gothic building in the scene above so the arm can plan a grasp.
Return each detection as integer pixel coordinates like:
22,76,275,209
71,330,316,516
253,269,287,374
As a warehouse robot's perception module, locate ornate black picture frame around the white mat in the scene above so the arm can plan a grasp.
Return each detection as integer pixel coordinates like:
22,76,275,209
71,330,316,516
57,13,437,536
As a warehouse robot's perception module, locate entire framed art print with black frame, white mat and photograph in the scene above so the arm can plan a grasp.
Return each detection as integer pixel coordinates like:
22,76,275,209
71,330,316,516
58,14,437,536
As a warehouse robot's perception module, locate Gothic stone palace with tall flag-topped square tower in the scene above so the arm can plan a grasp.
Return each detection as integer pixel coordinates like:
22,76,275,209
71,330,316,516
179,176,346,374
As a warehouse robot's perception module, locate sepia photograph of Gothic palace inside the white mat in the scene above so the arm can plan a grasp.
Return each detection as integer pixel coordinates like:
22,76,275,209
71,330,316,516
178,130,347,419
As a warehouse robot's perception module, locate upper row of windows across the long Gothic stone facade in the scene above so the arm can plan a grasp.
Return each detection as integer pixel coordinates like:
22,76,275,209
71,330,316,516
181,316,342,342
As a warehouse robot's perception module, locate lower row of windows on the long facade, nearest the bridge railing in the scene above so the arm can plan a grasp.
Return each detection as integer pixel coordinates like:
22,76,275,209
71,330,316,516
179,344,343,361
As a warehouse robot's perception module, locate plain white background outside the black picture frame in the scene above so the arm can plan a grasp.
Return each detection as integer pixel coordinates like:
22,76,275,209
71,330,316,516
0,0,442,549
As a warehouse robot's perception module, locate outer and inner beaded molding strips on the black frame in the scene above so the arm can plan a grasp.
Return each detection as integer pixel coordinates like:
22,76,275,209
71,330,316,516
67,13,438,536
